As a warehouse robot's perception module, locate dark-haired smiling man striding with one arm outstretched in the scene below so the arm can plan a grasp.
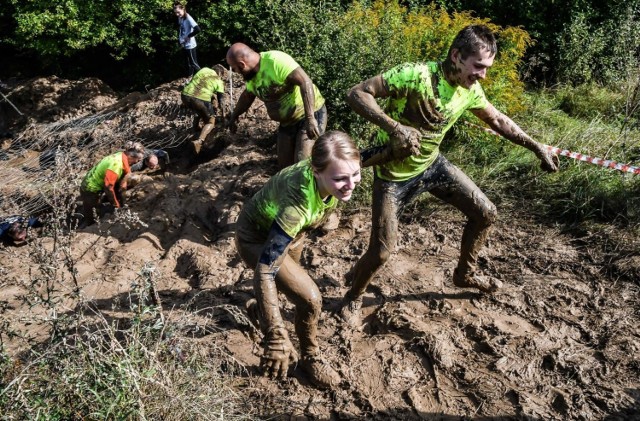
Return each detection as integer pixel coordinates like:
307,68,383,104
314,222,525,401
341,25,558,326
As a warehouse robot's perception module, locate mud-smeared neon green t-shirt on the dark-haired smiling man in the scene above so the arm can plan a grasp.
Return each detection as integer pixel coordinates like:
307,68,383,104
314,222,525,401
376,62,489,181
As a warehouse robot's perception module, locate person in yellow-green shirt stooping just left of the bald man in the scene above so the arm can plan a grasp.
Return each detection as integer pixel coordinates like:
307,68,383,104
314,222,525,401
181,67,225,154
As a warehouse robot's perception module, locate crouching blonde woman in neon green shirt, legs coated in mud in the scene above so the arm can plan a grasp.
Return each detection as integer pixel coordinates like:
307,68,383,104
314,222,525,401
236,131,360,388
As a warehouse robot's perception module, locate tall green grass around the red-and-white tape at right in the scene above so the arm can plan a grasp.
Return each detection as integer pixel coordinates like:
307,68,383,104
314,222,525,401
443,86,640,225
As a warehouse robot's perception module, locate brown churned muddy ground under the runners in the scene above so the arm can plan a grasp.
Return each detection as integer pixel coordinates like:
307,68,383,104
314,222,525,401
0,72,640,420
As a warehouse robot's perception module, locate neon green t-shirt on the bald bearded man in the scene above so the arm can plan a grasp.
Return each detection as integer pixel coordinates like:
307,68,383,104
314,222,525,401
246,51,324,127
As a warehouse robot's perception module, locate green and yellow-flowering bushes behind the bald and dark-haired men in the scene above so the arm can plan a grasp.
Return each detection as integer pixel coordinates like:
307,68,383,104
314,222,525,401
208,0,531,133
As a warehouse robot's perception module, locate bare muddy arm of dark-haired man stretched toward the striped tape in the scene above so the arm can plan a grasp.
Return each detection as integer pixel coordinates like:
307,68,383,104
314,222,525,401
471,104,558,172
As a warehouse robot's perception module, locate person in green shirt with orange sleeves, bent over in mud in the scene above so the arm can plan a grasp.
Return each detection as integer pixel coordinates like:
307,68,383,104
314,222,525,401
80,142,144,226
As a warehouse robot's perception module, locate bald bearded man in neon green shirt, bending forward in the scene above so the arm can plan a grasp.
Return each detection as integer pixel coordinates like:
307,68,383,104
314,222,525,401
227,43,327,168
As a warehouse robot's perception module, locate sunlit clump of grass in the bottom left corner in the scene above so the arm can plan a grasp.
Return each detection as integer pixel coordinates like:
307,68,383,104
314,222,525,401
0,267,257,420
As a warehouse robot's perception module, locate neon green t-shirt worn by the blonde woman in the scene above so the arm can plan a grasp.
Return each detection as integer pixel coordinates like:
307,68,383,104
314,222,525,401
242,158,338,238
